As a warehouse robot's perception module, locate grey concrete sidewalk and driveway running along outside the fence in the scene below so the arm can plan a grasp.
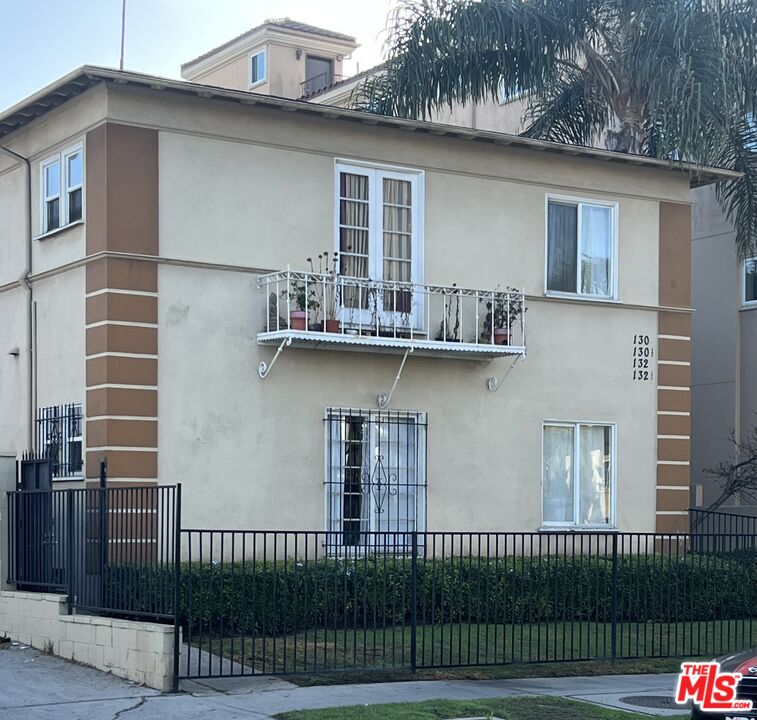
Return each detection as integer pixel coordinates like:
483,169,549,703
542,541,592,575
0,647,682,720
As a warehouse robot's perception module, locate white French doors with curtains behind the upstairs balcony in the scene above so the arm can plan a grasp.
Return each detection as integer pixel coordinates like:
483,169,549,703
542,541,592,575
335,163,425,329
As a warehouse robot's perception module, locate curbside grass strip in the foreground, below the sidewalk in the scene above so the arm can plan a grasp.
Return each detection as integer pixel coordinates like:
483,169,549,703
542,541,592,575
276,697,688,720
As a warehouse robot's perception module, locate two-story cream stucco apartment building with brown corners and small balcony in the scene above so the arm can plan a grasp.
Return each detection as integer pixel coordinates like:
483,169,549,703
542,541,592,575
0,49,728,544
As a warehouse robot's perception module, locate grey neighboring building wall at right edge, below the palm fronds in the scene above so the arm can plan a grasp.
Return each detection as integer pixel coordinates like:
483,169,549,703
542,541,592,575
691,188,757,513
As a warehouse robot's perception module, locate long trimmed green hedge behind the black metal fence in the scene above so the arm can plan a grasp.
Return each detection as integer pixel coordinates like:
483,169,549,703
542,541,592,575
105,555,757,634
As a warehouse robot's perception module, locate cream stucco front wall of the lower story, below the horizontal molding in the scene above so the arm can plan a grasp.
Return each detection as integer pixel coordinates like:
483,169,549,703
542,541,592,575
159,266,656,531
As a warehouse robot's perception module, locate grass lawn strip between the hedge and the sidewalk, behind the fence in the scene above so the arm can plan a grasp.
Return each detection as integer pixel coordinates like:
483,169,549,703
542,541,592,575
187,620,757,684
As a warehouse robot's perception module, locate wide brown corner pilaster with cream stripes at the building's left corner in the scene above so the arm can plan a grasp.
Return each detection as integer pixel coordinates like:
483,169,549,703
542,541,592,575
85,123,158,485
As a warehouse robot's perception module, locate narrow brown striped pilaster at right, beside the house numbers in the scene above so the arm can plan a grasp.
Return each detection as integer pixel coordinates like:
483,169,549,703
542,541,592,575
656,202,691,533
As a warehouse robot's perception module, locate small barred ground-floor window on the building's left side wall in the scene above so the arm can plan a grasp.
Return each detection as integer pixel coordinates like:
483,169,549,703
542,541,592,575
37,404,83,478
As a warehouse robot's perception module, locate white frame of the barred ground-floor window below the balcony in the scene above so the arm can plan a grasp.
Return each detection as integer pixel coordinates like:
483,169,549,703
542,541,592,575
323,407,428,555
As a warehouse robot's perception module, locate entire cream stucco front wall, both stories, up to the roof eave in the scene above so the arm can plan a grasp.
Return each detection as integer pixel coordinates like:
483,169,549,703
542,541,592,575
99,90,688,531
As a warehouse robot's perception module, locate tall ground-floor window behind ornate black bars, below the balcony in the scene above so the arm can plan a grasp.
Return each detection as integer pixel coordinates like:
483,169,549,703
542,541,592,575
326,408,426,553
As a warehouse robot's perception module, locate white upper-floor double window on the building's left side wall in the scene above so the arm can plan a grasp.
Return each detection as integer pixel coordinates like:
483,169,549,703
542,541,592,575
40,145,84,234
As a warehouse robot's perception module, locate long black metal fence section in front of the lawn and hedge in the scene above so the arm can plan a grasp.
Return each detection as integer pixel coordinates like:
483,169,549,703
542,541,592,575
174,529,757,677
